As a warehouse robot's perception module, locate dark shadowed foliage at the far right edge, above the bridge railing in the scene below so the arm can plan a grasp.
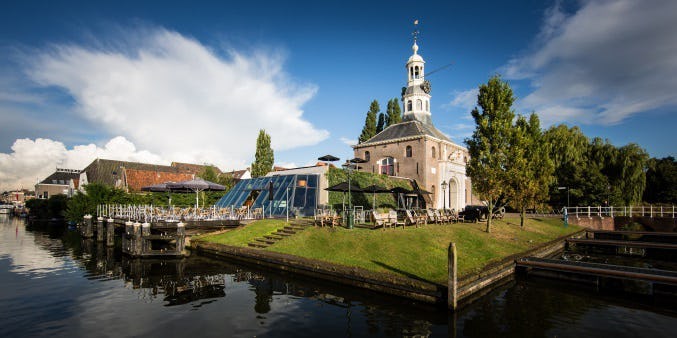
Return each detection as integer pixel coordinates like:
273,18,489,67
644,156,677,204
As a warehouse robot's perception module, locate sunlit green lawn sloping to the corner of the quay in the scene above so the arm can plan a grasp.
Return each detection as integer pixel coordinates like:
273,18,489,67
198,218,580,284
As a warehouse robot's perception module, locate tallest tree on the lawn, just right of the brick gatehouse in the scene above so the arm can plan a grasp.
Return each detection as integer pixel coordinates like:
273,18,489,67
465,75,515,232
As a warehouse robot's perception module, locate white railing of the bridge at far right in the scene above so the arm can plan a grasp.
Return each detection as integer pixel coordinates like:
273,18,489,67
562,205,677,218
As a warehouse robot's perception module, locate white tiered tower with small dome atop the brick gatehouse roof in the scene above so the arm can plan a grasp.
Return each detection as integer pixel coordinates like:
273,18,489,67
402,33,432,124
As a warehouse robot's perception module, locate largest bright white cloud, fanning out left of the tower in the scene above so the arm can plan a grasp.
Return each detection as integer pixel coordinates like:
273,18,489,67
27,29,329,170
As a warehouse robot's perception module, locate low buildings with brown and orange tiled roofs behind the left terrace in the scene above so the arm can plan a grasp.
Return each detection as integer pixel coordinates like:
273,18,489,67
79,159,221,192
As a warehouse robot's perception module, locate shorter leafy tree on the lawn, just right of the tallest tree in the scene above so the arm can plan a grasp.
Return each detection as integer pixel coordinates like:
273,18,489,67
508,113,555,228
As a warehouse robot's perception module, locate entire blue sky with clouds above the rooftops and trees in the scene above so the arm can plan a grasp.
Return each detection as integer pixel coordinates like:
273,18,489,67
0,0,677,191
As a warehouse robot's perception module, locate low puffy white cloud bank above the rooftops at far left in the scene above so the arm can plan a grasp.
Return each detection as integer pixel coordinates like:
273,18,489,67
0,136,164,191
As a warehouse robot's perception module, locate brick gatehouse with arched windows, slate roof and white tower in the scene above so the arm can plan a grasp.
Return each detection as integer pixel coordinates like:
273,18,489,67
353,34,472,210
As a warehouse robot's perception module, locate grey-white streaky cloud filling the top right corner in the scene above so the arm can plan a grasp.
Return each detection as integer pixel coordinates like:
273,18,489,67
503,0,677,124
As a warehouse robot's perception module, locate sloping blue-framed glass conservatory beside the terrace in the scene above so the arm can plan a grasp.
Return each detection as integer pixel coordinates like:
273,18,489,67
216,174,319,217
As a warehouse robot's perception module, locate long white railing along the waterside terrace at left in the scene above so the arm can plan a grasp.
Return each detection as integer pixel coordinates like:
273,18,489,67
96,204,265,222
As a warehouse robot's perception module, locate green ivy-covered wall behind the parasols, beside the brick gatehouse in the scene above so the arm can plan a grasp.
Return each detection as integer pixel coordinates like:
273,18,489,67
326,168,411,210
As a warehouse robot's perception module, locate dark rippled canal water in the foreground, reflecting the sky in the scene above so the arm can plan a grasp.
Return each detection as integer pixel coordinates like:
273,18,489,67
0,216,677,337
